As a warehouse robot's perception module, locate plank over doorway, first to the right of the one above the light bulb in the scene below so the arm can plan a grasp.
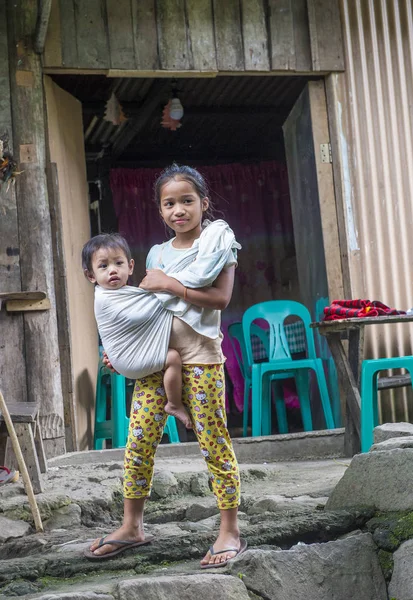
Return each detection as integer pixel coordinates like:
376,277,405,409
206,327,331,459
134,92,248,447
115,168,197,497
186,0,218,72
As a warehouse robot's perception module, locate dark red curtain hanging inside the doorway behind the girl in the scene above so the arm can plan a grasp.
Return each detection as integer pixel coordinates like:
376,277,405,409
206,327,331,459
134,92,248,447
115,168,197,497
110,161,294,410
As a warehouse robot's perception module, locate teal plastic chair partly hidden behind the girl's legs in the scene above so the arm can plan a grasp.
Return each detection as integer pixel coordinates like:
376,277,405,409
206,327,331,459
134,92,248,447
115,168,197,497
93,349,180,450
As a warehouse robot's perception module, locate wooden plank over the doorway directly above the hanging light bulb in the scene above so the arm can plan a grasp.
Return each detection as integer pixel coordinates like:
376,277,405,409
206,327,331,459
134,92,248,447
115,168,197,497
156,0,193,70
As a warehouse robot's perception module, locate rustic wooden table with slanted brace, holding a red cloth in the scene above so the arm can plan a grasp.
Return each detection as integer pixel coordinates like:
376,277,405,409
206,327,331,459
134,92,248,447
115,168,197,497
311,315,413,456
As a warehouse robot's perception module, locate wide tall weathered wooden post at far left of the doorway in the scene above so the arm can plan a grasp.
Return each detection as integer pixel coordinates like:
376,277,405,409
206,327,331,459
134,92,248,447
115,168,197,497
6,0,65,456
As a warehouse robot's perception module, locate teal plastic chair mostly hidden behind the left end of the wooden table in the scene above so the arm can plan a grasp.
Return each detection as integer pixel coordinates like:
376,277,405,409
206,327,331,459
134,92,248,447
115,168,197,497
314,298,342,427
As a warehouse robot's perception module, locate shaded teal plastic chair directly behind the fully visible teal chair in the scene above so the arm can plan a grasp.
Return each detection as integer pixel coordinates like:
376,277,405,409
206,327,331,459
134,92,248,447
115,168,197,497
228,323,294,437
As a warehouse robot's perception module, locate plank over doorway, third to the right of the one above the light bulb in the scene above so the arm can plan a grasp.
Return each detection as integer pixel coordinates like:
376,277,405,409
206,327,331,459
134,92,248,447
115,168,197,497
241,0,270,71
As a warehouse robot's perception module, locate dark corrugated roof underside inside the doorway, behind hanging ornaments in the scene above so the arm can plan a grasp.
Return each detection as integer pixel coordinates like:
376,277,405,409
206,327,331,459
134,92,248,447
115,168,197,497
50,75,316,162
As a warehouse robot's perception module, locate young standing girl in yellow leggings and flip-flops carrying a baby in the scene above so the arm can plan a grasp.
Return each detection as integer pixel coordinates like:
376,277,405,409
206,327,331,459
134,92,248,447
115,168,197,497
86,165,246,568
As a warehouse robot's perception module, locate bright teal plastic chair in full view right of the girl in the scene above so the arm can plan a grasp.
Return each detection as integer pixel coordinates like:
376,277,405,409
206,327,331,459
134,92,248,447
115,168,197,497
242,300,334,436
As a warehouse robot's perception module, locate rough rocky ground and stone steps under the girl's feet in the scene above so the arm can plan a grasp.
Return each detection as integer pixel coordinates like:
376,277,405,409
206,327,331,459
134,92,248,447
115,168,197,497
0,424,413,600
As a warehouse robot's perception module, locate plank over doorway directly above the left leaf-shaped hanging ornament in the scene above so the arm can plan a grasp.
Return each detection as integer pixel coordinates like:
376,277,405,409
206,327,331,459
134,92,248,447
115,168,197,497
106,0,135,69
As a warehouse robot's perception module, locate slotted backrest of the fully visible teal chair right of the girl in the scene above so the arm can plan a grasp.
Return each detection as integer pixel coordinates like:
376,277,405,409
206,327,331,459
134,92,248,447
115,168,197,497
242,300,316,364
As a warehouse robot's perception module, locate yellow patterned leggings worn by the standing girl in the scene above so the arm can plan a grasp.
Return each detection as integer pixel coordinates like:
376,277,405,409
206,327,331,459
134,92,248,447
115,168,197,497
124,364,240,509
